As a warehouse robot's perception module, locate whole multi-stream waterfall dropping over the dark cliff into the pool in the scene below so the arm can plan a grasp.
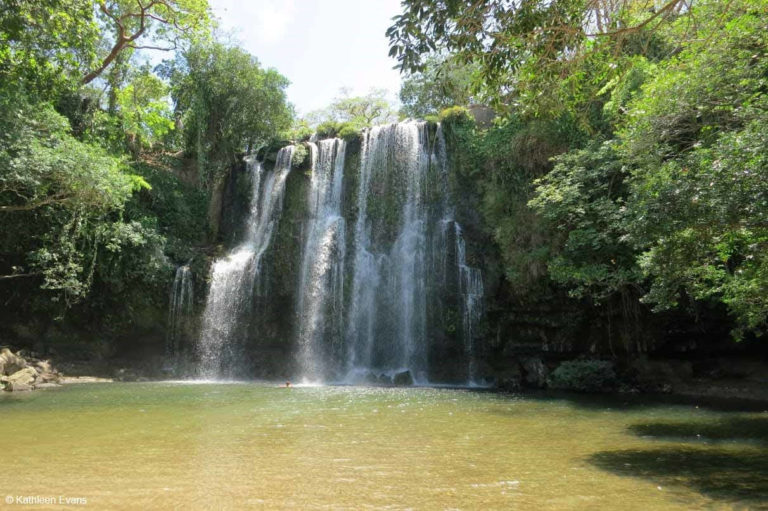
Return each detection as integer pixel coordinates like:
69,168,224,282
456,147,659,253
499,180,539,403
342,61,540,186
198,121,484,383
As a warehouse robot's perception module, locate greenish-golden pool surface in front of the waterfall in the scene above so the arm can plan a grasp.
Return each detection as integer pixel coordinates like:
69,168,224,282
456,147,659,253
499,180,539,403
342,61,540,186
0,383,768,510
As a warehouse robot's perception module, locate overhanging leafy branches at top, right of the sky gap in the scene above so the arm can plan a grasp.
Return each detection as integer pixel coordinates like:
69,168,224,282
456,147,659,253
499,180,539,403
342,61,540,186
387,0,690,114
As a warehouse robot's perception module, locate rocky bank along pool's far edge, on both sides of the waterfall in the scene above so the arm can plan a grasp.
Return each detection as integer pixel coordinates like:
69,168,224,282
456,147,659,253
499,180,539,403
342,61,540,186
0,348,768,408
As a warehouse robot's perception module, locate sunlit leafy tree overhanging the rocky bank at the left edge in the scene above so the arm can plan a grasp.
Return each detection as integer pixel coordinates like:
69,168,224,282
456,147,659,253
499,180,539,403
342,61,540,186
0,93,167,308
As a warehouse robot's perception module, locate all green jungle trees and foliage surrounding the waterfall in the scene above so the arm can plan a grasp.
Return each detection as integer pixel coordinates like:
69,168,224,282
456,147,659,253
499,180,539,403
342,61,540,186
0,0,768,352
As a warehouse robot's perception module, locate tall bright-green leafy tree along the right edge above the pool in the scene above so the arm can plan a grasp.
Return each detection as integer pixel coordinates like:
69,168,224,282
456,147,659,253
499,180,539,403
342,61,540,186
622,2,768,337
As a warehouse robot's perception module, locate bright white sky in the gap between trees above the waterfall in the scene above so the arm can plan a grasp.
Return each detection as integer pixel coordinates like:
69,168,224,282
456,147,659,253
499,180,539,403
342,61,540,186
210,0,400,115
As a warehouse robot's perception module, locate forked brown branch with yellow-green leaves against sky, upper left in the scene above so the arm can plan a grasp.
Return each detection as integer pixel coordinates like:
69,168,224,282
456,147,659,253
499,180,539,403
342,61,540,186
82,0,210,84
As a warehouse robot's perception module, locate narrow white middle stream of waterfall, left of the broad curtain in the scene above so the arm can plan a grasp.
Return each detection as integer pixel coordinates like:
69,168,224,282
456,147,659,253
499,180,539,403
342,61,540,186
297,139,346,381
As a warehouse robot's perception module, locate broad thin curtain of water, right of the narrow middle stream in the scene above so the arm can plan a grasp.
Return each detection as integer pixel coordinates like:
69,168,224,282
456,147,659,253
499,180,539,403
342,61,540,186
346,122,430,381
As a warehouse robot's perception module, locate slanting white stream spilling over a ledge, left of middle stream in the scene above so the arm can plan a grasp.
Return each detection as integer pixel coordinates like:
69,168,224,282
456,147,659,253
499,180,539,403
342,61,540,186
198,146,293,379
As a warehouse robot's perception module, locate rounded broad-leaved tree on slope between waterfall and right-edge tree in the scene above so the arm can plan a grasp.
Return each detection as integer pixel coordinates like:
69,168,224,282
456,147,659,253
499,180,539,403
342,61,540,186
529,142,641,302
